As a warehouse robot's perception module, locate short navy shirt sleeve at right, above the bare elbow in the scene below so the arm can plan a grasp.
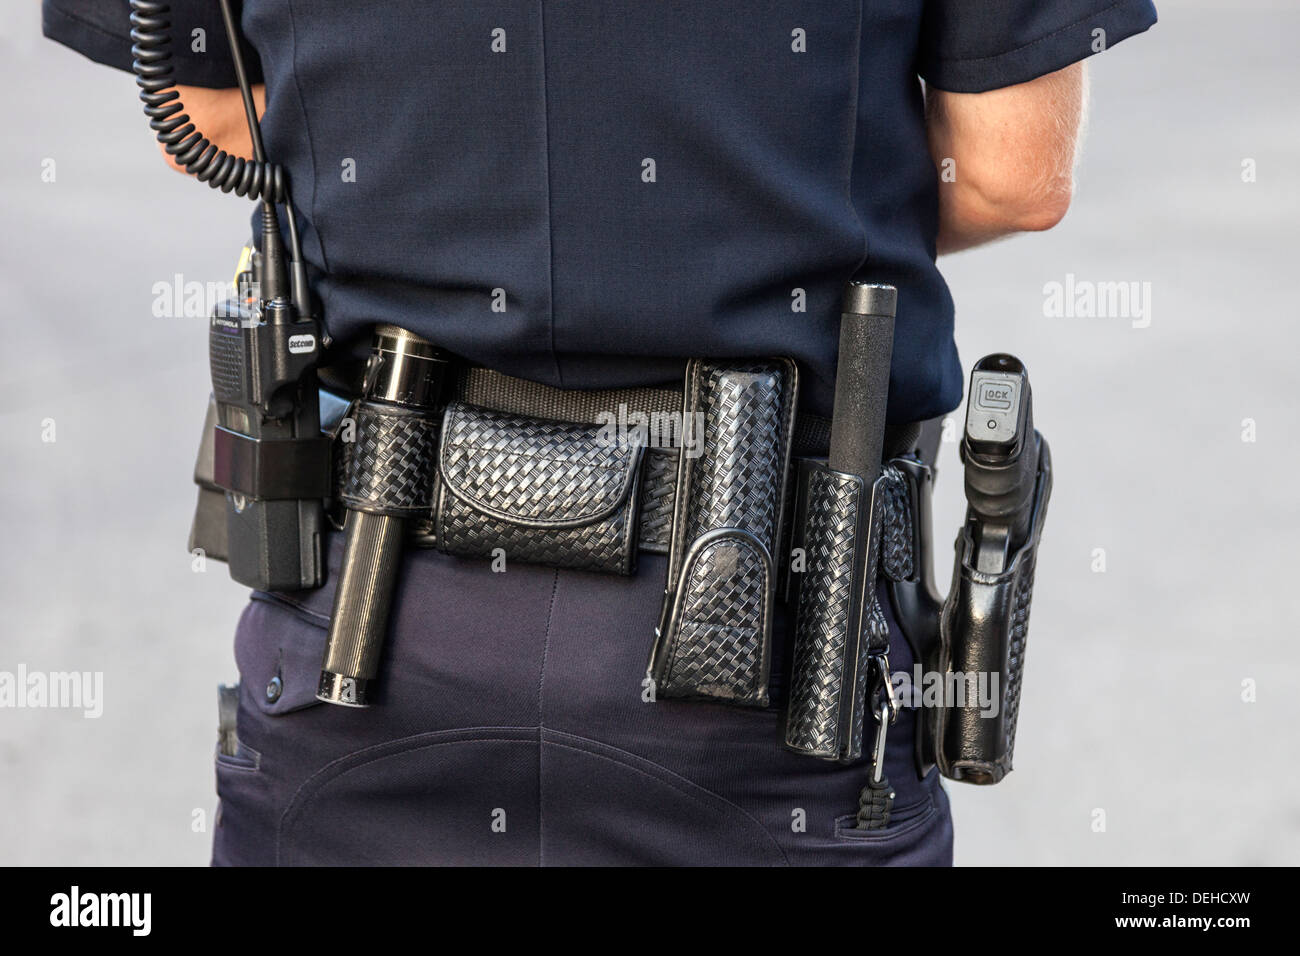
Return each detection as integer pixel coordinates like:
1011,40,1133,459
918,0,1156,92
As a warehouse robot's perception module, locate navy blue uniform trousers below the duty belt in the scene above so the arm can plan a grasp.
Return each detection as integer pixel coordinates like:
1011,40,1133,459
213,536,953,866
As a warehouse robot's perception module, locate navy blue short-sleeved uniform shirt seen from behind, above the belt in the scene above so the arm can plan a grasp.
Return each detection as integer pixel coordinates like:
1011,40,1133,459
44,0,1156,421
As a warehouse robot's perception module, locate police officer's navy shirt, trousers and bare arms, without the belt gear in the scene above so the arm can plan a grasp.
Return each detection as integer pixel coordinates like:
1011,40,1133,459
43,0,1156,865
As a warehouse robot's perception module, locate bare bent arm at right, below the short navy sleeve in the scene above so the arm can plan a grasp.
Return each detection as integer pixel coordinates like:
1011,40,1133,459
926,64,1087,254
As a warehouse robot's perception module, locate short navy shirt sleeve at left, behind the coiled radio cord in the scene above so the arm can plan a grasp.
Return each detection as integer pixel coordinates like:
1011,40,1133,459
40,0,261,87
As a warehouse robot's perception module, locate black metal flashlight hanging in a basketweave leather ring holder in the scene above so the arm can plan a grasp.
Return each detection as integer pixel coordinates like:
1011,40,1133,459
316,325,449,708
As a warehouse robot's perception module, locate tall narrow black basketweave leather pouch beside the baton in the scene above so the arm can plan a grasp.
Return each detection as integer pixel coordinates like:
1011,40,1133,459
649,359,798,706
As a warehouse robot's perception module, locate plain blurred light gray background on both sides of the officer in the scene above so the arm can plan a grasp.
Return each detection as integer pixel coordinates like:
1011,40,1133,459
0,0,1300,864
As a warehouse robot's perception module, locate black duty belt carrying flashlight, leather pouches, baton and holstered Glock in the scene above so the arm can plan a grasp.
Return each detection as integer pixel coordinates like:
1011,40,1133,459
191,282,1052,829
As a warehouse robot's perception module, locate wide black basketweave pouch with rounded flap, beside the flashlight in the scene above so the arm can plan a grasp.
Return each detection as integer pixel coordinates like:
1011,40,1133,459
434,402,645,575
